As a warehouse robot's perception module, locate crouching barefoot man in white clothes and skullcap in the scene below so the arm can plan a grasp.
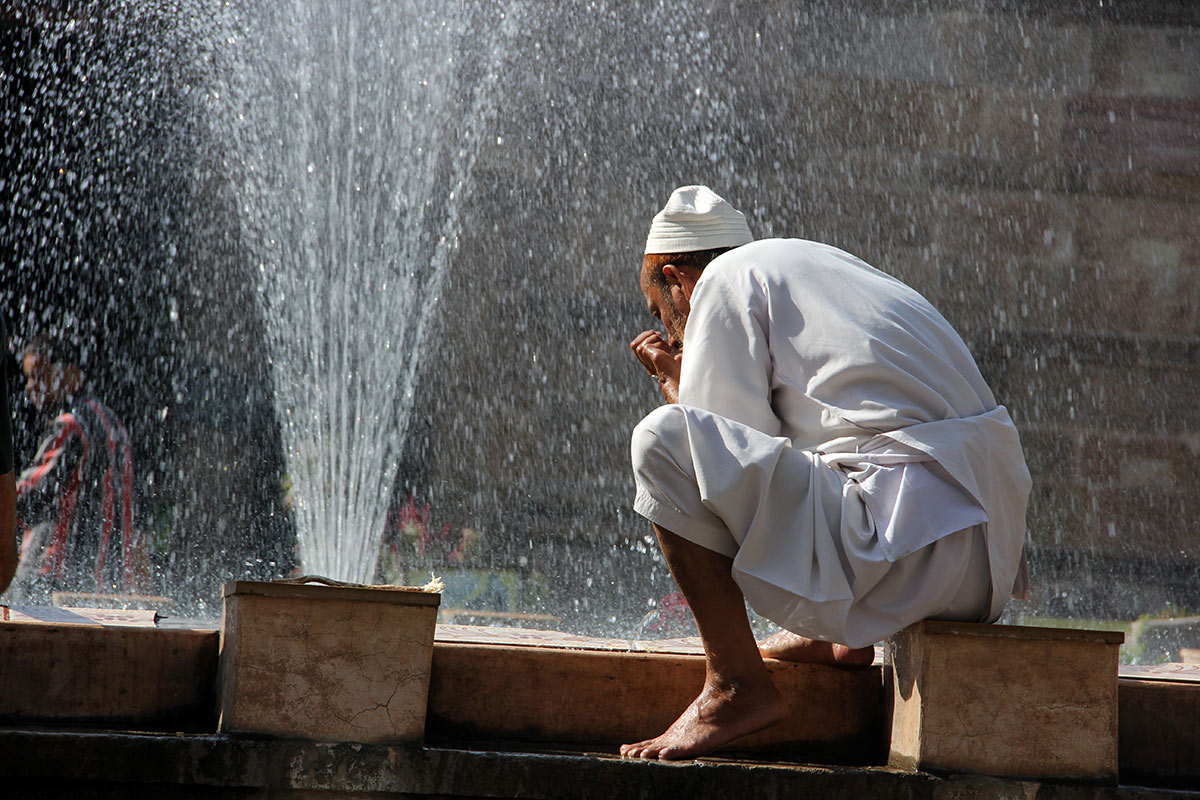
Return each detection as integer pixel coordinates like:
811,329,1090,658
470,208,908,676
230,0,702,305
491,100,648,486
622,186,1030,759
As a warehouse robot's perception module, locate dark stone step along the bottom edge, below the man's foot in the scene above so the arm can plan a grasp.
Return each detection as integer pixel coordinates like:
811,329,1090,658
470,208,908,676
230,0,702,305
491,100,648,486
0,729,1200,800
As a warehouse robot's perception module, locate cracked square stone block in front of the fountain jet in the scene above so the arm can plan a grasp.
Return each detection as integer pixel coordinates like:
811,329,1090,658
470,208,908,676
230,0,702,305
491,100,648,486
218,582,440,742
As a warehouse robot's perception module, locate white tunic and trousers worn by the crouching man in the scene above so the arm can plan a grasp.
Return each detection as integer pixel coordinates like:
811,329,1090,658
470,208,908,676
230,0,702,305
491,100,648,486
632,240,1030,646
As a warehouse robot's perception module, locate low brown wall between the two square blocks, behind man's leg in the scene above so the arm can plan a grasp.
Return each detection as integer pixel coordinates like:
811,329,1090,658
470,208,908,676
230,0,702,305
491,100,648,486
428,642,883,764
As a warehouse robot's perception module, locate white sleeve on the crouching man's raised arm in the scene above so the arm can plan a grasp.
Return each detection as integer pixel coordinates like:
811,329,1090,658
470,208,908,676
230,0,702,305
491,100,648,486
679,271,782,437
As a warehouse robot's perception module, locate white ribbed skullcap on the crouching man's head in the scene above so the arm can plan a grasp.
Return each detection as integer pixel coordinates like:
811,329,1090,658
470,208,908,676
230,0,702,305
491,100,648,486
646,186,754,254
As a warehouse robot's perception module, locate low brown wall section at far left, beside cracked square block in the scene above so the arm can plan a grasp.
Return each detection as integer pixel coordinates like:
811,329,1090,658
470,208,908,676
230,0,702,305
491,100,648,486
0,622,217,730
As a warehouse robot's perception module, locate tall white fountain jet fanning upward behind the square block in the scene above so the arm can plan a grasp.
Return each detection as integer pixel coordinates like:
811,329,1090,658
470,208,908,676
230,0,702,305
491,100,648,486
224,2,525,582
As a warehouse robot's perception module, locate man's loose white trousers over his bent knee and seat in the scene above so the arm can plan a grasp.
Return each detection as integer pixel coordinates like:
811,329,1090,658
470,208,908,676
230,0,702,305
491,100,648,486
632,404,990,646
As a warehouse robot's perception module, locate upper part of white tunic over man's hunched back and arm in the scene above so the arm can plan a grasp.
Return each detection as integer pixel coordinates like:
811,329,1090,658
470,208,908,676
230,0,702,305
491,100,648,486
679,239,996,451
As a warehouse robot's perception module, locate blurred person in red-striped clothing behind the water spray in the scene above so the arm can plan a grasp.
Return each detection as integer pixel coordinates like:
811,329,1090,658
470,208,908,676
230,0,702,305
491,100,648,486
17,336,144,602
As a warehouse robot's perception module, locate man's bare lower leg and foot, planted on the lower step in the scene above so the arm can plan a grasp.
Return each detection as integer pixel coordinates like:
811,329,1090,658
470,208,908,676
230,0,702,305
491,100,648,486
620,525,787,759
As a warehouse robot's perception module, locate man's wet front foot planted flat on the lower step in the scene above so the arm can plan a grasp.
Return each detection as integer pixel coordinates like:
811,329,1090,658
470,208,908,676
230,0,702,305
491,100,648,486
620,679,787,759
